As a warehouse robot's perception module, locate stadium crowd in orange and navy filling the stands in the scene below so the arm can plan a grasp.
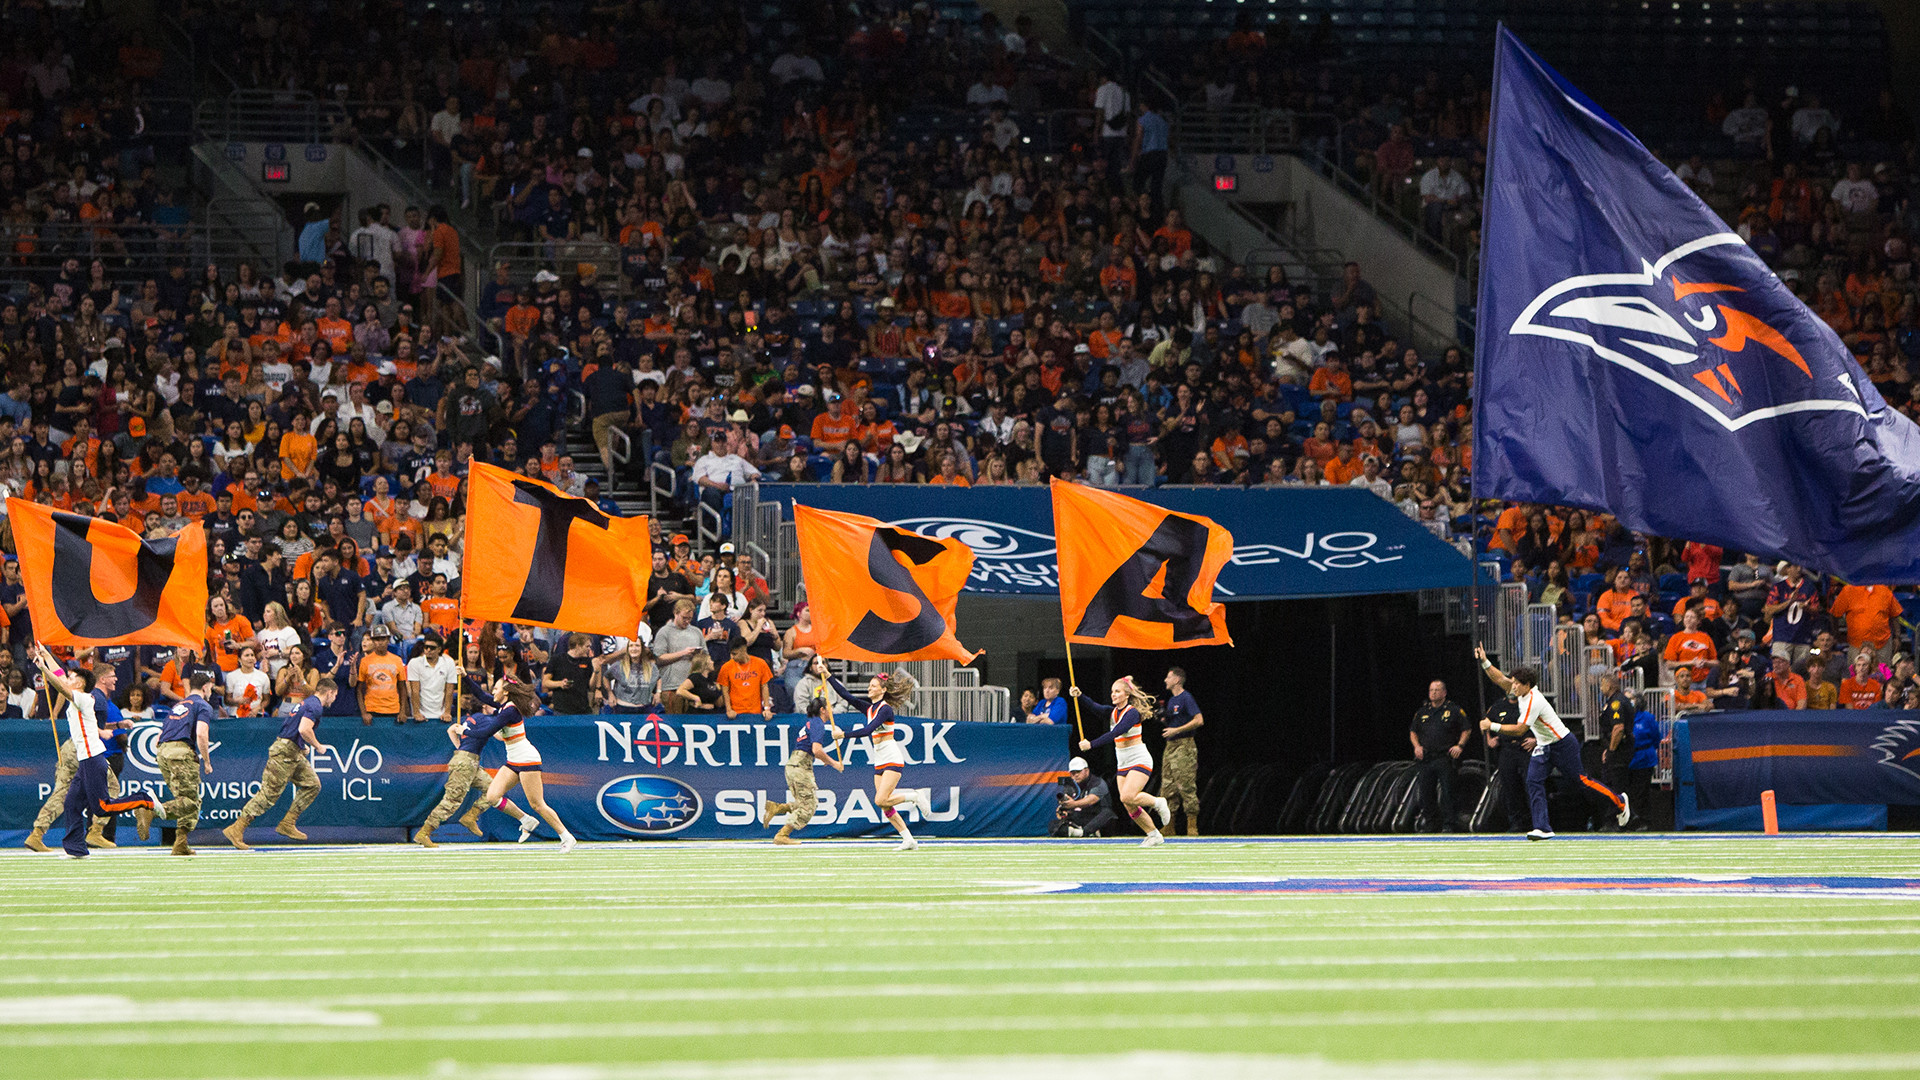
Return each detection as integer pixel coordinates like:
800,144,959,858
0,4,1920,719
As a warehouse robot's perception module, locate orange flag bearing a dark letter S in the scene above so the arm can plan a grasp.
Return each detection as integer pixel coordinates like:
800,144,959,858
793,503,979,663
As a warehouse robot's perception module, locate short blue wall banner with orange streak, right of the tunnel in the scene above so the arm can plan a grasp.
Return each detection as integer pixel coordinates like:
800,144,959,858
1686,709,1920,809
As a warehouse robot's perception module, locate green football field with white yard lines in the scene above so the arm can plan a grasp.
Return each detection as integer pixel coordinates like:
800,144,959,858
0,834,1920,1080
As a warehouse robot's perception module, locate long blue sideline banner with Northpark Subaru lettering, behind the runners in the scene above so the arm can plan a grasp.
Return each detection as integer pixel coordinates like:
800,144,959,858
0,717,1068,844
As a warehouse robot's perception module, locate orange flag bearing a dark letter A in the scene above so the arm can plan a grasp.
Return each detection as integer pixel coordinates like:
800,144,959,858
1052,480,1233,650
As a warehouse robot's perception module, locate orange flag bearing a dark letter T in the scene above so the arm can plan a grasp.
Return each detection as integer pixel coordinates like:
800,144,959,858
461,461,653,638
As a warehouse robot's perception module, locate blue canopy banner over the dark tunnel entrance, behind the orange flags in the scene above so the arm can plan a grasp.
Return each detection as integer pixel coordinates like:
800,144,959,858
760,484,1473,600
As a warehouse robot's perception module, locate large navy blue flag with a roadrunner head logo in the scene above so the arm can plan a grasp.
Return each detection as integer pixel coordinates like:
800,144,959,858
1475,27,1920,582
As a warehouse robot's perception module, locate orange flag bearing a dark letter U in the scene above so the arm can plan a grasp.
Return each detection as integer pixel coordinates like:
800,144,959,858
6,500,207,648
